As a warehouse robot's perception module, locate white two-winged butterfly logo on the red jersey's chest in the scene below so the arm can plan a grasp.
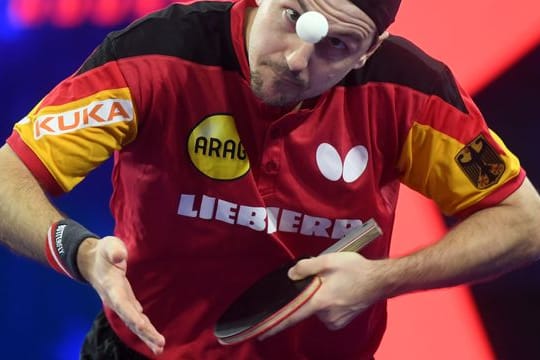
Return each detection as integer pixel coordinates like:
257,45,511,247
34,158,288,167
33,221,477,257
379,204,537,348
316,143,369,183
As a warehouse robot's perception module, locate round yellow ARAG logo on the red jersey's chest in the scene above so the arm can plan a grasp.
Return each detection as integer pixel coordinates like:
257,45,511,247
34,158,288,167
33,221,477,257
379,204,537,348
188,114,249,180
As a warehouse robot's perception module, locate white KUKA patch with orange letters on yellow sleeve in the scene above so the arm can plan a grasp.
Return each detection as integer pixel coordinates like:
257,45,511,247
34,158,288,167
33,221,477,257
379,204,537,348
34,99,134,139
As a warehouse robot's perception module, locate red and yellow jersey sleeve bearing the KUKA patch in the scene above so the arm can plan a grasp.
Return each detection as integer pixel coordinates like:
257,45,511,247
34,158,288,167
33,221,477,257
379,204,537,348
7,35,137,194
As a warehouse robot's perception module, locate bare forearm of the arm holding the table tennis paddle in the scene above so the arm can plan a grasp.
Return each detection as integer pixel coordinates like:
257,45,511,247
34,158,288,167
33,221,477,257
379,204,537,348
379,181,540,297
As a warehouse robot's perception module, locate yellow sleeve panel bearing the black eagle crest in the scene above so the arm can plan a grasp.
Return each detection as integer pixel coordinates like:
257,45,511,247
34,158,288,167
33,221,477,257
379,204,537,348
398,122,521,215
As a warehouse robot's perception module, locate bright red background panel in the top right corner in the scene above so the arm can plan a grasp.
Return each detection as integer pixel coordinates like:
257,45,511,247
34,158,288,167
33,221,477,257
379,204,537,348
392,0,540,93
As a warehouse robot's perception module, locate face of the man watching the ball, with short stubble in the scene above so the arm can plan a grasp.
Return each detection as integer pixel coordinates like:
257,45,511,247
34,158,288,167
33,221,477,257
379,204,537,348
246,0,376,106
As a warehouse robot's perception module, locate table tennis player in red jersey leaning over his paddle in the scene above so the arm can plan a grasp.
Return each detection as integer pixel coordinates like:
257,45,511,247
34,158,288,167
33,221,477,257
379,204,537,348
0,0,540,359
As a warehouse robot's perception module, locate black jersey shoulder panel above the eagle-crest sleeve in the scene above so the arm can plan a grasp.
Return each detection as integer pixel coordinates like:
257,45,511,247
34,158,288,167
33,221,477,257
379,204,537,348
341,35,468,113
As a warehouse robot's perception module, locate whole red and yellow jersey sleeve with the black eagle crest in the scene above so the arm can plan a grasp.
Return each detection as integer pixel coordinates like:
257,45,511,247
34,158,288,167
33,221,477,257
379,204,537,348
398,69,525,217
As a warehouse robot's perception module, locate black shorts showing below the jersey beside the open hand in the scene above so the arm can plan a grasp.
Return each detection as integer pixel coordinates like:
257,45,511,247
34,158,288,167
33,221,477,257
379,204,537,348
80,311,148,360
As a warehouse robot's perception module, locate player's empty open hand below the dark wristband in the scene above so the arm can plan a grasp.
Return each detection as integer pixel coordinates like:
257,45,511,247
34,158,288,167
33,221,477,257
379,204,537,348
77,236,165,355
